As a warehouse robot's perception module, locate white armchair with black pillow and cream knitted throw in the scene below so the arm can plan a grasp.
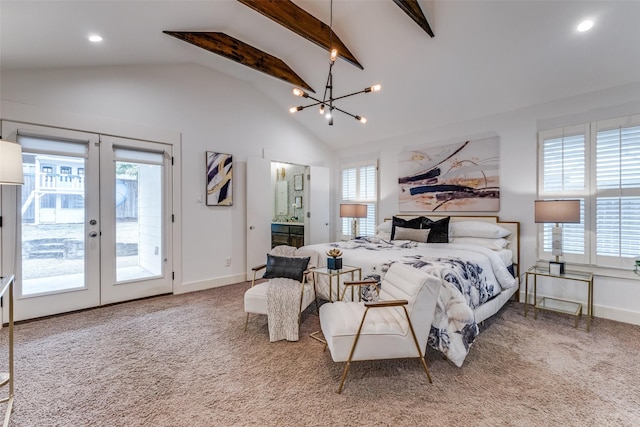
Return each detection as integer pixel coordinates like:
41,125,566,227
244,246,317,341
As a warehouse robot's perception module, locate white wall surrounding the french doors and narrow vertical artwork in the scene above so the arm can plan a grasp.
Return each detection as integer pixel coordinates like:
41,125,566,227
0,65,331,292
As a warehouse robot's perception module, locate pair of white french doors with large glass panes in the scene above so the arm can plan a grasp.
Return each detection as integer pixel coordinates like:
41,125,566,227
2,122,172,320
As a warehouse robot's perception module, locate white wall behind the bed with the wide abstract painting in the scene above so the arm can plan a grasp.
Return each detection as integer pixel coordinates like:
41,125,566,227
334,82,640,324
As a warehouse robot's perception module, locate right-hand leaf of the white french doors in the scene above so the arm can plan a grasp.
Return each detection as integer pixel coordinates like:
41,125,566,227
100,136,172,304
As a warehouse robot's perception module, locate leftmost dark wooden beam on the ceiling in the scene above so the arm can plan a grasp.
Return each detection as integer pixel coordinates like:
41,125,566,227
163,31,315,93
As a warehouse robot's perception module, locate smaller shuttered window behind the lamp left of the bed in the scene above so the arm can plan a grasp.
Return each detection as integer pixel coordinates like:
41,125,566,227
340,160,378,241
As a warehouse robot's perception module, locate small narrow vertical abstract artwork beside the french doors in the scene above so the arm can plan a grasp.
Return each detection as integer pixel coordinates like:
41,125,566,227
207,151,233,206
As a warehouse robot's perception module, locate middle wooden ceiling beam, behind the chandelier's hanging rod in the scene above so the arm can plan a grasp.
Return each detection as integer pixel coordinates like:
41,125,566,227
238,0,362,70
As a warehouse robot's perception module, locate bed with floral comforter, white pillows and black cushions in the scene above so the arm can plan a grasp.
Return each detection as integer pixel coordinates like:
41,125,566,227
300,215,520,367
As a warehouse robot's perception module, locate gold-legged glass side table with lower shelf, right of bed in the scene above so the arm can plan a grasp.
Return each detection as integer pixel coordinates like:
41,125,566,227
524,266,593,332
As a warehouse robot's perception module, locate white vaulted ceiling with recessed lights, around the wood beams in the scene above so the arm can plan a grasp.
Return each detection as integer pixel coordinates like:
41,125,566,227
0,0,640,147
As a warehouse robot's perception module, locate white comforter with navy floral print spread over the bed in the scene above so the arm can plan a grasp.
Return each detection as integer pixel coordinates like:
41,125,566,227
304,237,516,366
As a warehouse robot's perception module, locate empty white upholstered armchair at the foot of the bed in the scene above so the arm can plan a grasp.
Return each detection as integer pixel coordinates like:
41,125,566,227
320,263,441,393
